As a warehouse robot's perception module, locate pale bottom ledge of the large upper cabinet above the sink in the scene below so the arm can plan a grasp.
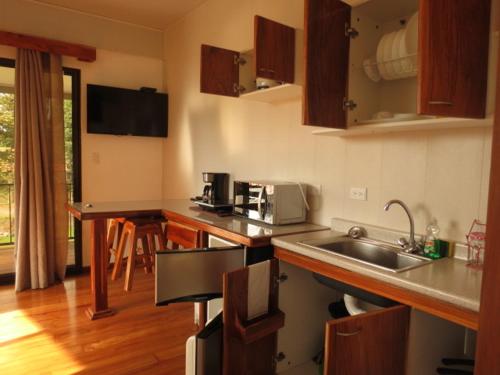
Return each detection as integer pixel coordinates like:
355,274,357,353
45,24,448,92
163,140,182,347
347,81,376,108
312,117,493,137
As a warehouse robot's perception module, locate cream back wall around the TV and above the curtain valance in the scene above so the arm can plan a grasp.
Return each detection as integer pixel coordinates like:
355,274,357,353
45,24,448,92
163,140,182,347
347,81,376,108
0,0,165,265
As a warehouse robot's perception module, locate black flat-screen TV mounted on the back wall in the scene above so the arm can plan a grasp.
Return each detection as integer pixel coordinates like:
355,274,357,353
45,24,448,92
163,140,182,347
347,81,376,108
87,85,168,137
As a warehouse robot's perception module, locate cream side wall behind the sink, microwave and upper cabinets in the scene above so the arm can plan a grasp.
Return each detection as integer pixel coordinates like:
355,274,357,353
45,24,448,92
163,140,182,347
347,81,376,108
164,0,495,241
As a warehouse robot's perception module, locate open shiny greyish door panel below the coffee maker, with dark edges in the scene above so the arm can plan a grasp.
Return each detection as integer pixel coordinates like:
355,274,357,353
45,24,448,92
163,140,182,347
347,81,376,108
155,246,245,306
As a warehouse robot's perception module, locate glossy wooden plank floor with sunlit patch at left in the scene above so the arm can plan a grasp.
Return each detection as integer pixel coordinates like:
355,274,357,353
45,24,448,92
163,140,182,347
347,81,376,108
0,269,195,375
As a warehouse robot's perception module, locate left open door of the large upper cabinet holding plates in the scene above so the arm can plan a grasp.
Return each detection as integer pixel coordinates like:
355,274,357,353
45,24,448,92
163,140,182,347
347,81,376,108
303,0,351,129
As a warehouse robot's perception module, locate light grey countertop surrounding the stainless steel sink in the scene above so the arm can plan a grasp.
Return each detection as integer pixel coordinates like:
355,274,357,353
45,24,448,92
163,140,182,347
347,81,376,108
271,230,482,312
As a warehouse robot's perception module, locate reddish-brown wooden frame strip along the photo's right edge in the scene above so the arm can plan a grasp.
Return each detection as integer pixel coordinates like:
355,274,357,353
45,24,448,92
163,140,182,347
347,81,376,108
474,39,500,375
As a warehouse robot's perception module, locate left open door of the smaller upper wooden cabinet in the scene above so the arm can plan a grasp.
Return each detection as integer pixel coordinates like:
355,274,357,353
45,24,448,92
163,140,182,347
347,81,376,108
200,44,240,97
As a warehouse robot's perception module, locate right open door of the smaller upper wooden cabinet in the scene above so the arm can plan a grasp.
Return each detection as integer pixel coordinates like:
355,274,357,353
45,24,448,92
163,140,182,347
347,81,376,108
254,16,295,83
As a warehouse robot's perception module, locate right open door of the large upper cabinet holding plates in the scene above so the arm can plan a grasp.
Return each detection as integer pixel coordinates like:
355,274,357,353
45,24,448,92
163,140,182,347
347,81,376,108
418,0,490,118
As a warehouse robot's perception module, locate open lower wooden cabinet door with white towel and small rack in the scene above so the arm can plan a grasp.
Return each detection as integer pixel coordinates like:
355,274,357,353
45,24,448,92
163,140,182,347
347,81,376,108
223,259,285,375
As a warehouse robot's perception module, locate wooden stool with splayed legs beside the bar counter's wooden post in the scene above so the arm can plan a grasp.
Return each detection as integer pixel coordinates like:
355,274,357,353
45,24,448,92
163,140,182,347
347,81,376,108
111,218,166,291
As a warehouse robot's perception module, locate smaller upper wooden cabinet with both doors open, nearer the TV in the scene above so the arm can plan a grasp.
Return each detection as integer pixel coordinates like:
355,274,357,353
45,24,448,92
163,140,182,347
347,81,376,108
200,16,295,97
